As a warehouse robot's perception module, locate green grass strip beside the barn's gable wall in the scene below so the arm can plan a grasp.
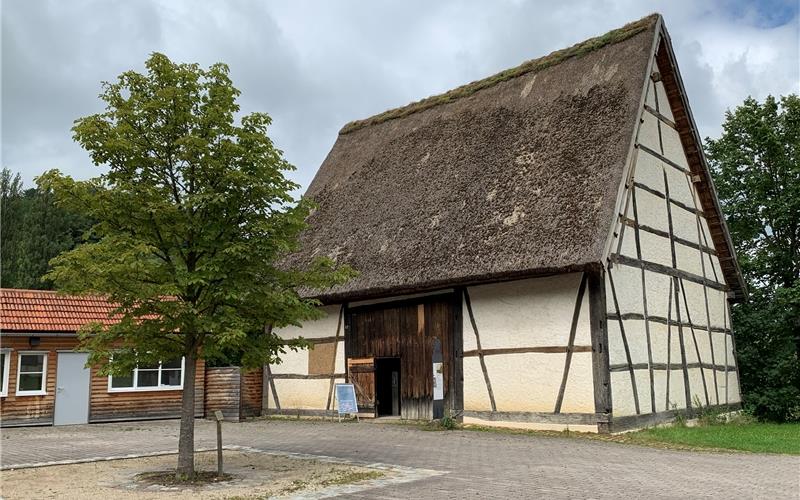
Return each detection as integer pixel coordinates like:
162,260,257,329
621,423,800,455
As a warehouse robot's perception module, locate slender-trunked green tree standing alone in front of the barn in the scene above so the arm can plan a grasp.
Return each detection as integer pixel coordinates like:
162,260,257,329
38,53,352,478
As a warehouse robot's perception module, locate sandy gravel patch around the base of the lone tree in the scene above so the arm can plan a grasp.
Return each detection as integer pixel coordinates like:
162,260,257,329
0,450,392,500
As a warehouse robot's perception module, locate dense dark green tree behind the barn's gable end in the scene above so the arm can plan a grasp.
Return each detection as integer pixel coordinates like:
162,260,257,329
706,94,800,420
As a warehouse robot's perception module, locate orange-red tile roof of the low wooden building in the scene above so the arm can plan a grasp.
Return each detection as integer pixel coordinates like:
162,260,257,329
0,288,122,332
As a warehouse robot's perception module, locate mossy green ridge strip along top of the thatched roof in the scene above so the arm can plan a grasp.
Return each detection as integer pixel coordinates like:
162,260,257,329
339,14,658,134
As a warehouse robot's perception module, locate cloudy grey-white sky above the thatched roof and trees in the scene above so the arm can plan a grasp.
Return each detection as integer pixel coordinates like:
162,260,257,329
1,0,800,187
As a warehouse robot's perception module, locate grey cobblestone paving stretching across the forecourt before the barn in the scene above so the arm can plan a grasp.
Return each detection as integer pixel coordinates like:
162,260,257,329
0,420,800,500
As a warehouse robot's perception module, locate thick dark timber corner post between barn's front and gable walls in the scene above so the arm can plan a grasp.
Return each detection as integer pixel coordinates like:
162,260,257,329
588,267,612,434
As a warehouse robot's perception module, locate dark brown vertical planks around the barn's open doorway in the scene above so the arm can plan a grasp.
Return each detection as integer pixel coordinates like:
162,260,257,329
345,294,457,420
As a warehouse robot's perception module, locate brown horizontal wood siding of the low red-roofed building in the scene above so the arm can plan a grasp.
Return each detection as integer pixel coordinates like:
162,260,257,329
0,334,205,426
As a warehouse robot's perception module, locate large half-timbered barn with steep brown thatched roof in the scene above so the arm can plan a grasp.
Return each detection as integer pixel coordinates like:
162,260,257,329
262,15,746,432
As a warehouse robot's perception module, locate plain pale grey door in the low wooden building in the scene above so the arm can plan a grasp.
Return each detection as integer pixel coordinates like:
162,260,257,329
53,352,89,425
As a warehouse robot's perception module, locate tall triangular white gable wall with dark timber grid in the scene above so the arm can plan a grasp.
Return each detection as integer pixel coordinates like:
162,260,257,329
606,56,740,417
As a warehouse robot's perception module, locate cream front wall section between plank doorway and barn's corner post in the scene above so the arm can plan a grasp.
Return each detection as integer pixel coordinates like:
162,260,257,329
463,273,596,430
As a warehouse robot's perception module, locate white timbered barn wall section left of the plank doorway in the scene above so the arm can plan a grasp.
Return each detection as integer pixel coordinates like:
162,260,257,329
263,305,345,414
